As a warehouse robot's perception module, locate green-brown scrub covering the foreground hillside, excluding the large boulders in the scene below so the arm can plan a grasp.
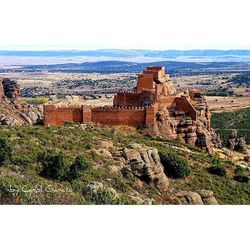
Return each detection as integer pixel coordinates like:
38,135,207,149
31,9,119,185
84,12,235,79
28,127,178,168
0,125,250,204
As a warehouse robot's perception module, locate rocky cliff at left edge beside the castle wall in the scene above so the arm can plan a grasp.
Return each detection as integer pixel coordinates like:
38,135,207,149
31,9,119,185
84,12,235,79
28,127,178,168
0,78,42,125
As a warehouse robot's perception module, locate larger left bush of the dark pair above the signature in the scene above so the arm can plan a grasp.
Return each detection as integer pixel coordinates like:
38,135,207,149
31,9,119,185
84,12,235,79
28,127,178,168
38,152,69,181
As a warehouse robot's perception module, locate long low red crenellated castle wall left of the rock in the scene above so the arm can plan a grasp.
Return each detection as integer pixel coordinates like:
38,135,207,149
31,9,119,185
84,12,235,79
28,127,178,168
44,104,158,128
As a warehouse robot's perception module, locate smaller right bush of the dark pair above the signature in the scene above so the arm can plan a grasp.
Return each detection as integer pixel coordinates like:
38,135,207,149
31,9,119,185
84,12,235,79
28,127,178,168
67,155,90,181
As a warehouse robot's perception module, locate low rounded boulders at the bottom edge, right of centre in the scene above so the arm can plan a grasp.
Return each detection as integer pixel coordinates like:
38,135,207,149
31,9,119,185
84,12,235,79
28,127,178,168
176,189,218,205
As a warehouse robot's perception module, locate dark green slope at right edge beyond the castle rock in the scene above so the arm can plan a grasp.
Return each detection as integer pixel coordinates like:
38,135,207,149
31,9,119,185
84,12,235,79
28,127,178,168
211,108,250,144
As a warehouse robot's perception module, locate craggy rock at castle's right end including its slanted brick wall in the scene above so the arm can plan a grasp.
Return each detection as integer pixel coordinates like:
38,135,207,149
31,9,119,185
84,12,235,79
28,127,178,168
147,83,222,154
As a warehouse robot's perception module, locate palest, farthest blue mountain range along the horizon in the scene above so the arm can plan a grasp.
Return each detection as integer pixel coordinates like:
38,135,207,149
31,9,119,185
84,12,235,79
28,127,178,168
0,49,250,65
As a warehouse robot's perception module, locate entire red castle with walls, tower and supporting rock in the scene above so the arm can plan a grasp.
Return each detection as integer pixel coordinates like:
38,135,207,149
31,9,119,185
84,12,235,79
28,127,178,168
44,67,219,151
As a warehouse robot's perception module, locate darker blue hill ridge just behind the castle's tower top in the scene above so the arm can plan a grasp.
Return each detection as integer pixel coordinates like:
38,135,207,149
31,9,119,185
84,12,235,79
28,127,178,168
0,61,250,75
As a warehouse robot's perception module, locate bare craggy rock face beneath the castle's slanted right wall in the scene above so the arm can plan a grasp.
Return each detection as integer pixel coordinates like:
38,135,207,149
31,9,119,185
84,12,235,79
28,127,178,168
149,96,222,153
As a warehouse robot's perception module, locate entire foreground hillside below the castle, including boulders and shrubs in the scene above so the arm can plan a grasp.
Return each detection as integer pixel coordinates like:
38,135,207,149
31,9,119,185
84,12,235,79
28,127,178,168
0,125,250,204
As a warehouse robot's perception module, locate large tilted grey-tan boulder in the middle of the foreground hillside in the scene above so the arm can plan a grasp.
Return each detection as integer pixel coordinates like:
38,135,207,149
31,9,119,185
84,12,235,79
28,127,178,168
122,144,169,192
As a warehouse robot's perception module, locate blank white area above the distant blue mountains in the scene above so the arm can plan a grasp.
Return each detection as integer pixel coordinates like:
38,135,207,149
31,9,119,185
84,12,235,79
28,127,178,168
0,0,250,49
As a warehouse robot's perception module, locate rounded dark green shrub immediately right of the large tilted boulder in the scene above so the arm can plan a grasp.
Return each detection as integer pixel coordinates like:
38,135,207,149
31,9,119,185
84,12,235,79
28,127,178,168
160,152,190,179
